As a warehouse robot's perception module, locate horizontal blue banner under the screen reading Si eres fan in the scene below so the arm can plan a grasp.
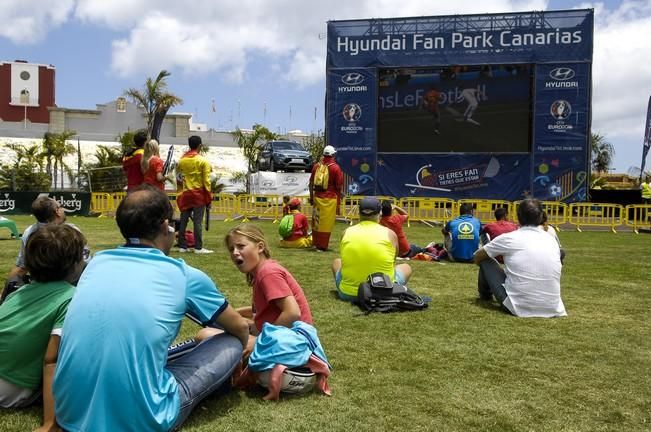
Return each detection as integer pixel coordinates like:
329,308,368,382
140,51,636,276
377,154,531,201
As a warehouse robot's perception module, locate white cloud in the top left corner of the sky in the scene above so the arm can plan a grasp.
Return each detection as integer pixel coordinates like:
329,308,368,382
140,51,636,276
0,0,74,44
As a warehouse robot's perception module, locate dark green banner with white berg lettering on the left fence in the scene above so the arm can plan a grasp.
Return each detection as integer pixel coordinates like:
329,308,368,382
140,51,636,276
0,192,90,216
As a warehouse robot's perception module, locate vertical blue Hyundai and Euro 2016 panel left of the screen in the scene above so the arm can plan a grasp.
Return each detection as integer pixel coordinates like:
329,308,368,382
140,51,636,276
326,69,378,195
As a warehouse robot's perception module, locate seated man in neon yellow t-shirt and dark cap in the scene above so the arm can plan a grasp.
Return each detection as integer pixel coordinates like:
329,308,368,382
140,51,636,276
332,197,411,302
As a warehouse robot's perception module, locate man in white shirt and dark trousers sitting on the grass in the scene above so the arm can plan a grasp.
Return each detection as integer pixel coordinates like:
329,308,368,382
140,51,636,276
474,199,567,318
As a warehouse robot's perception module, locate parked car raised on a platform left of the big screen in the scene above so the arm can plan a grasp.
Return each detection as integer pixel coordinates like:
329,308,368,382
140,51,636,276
258,141,313,171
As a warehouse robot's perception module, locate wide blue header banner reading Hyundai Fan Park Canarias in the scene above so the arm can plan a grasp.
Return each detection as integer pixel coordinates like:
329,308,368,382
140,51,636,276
327,9,594,67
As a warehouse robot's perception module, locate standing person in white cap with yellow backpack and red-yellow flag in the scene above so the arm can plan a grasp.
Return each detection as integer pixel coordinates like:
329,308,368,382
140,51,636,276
310,145,344,251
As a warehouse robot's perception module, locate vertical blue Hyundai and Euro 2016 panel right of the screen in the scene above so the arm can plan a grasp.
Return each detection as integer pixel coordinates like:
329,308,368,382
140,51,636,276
532,63,590,202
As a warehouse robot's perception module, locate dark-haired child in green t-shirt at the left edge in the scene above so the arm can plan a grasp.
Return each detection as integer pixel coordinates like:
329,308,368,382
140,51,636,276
0,224,86,431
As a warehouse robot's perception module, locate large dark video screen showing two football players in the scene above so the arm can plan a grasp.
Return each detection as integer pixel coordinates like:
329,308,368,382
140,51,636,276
378,64,533,153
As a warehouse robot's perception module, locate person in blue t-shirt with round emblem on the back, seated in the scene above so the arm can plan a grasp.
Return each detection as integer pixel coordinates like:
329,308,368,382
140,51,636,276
441,203,481,263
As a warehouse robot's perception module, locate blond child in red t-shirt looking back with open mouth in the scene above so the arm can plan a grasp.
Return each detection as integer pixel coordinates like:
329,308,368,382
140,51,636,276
224,224,312,358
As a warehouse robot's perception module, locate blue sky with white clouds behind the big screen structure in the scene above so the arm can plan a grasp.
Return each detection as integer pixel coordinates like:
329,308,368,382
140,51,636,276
0,0,651,172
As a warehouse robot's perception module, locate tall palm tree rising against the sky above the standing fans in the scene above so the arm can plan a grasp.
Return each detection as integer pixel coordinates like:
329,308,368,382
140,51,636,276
124,70,183,140
